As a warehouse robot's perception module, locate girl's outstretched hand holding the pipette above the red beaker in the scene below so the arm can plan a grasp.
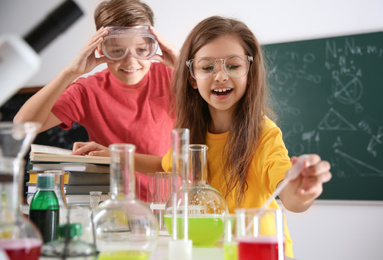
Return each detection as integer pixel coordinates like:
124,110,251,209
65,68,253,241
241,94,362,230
279,154,331,212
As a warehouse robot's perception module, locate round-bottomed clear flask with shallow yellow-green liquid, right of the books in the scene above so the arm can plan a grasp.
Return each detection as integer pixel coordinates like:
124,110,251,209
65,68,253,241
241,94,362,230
93,144,159,260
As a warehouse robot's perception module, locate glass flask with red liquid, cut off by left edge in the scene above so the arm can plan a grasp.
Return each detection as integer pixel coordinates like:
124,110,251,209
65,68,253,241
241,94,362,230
0,122,42,260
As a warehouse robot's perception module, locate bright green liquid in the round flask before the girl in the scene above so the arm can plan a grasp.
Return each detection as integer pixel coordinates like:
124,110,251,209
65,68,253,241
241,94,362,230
164,214,223,246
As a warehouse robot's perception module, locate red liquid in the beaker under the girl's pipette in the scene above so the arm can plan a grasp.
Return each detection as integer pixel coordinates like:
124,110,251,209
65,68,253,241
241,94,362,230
238,237,282,260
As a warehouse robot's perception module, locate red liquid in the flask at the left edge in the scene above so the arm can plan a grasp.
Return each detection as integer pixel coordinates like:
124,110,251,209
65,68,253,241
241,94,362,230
0,239,41,260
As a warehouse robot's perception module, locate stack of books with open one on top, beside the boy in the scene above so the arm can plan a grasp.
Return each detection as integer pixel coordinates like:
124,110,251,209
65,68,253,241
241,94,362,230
27,144,110,204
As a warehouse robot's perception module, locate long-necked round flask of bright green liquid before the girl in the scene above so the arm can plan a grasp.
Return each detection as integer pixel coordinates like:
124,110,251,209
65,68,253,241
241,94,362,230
165,144,229,246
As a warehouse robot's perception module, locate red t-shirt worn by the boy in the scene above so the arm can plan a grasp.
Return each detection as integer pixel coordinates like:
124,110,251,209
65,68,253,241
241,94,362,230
52,63,174,200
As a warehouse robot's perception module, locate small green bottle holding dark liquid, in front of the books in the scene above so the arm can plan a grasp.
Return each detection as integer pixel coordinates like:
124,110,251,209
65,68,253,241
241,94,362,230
29,174,60,243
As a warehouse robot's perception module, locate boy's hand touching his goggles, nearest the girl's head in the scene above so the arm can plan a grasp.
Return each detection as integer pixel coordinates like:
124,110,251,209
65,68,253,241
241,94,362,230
149,26,179,69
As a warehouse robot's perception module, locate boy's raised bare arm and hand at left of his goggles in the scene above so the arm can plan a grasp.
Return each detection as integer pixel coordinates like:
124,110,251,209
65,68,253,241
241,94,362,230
13,28,108,132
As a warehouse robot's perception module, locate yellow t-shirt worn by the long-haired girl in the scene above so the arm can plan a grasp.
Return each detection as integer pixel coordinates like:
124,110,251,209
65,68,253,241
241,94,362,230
162,118,293,258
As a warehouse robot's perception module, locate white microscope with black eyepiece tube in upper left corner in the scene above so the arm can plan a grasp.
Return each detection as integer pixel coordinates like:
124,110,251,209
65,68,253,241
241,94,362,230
0,0,83,106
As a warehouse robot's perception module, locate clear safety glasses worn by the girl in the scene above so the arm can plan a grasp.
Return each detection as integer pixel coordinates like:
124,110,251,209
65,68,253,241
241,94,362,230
186,55,253,79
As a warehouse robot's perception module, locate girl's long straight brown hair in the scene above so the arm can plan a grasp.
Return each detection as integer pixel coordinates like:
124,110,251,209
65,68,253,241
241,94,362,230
172,16,274,206
